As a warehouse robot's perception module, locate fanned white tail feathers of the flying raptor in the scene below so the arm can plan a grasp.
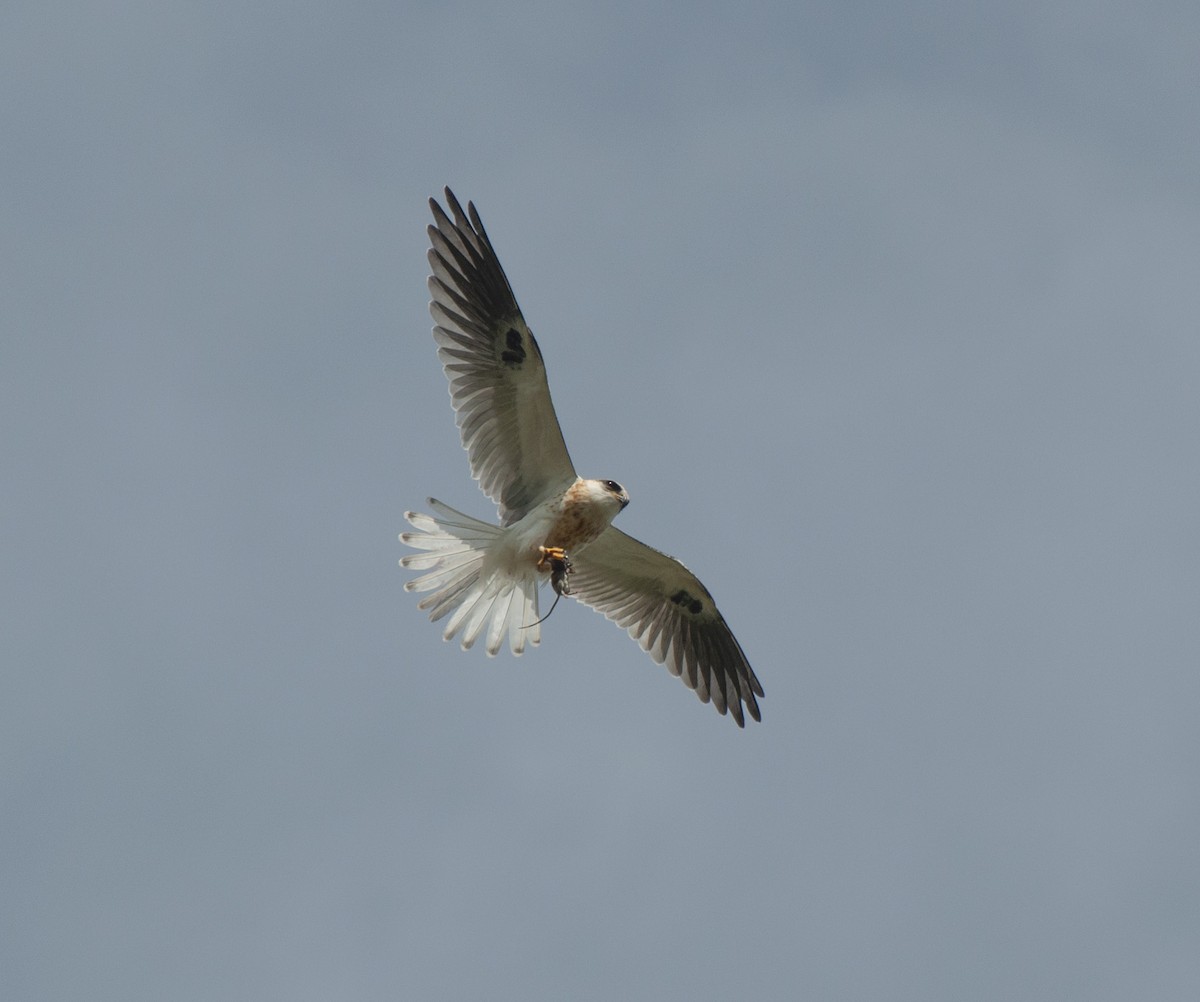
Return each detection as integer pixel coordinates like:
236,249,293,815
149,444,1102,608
400,498,541,656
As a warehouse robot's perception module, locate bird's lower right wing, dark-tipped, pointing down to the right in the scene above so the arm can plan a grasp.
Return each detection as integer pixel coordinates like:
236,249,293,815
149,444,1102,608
570,526,762,727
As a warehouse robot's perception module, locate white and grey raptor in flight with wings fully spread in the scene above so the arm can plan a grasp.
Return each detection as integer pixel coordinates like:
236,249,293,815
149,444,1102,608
400,188,762,727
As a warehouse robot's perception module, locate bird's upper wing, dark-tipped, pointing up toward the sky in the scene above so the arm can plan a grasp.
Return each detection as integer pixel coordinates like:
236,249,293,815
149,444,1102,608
428,188,575,526
